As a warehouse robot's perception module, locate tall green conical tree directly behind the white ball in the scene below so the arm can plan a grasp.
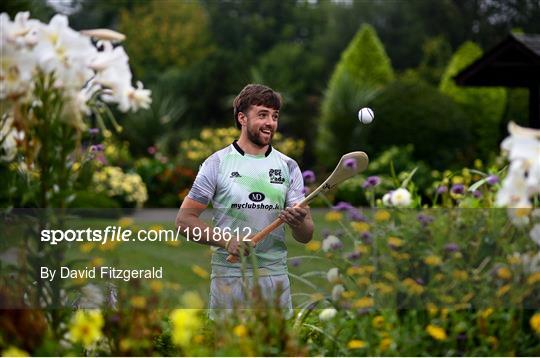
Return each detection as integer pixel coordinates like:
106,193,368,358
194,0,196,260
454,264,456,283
317,25,394,165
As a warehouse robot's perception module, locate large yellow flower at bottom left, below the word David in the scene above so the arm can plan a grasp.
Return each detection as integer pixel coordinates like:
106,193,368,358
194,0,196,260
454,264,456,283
69,310,104,347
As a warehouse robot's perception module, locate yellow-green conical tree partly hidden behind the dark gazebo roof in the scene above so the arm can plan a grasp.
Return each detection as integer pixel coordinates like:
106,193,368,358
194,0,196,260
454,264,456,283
439,42,506,159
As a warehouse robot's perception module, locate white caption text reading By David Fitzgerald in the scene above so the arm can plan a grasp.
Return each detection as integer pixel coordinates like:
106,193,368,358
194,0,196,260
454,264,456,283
40,266,163,282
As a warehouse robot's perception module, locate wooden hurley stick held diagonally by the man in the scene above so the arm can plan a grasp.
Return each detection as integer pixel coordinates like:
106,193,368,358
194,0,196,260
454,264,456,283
227,152,369,263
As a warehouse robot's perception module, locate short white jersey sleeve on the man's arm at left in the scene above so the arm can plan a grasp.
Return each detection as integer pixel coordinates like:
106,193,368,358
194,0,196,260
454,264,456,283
187,154,219,205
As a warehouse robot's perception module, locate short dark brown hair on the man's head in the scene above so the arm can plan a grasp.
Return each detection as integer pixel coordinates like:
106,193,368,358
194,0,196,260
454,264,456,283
233,83,283,129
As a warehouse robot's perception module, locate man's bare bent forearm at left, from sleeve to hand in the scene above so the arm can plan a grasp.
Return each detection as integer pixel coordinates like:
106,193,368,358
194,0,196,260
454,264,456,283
176,197,248,255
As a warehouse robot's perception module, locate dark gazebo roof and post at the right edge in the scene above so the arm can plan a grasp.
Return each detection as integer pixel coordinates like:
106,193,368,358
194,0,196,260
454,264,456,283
454,34,540,128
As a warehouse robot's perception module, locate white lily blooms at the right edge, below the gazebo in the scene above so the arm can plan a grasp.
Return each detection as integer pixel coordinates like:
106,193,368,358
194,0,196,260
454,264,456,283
496,122,540,208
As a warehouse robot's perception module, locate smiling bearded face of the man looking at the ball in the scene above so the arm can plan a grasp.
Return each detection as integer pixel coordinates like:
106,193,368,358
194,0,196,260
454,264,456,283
241,106,279,147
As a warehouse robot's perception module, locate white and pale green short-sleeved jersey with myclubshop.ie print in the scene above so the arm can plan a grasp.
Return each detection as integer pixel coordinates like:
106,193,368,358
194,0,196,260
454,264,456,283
188,141,304,277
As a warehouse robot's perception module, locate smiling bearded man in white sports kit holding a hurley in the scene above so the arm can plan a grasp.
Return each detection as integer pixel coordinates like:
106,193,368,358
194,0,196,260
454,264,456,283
176,84,313,316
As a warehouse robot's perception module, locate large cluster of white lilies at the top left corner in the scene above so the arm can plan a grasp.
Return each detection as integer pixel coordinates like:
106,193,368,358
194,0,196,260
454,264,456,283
0,12,151,114
